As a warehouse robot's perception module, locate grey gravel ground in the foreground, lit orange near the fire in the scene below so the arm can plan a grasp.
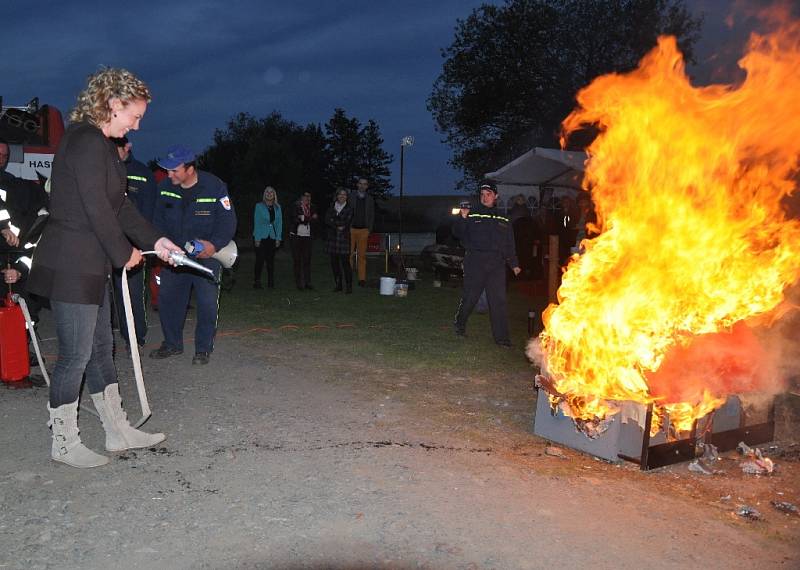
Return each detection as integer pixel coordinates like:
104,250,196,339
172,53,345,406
0,318,800,569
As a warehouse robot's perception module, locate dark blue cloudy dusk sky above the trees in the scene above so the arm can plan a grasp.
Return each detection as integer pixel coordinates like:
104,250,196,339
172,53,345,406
0,0,772,194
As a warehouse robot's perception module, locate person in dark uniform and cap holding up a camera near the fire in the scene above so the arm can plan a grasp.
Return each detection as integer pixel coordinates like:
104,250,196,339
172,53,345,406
453,183,520,348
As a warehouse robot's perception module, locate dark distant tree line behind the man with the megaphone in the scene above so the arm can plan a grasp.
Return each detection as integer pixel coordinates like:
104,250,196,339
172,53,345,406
198,108,393,235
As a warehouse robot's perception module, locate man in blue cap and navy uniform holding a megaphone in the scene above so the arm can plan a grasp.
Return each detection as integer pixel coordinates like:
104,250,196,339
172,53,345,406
150,145,236,364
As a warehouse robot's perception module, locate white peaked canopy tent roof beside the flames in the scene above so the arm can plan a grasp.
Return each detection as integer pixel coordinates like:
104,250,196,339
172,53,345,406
486,147,589,208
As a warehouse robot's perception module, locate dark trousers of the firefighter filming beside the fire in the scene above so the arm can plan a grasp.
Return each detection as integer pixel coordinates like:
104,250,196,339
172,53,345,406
455,251,509,344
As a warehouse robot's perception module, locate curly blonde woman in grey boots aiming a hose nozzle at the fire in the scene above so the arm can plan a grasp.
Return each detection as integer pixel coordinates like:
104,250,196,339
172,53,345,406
28,68,180,467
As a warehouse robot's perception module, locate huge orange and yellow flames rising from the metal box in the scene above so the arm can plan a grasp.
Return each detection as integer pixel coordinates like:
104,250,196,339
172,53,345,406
540,10,800,430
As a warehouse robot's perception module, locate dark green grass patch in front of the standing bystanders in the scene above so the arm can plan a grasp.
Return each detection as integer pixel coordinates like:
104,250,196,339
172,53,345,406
220,242,542,373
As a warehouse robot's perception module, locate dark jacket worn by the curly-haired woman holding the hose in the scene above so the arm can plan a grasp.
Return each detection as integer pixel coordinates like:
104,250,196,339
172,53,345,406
28,122,162,305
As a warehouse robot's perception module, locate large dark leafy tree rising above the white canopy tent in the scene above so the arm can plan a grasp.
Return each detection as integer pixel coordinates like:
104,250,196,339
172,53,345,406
428,0,702,186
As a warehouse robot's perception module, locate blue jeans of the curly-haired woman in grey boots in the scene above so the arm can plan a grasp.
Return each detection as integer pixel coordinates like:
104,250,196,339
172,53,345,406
50,285,117,409
